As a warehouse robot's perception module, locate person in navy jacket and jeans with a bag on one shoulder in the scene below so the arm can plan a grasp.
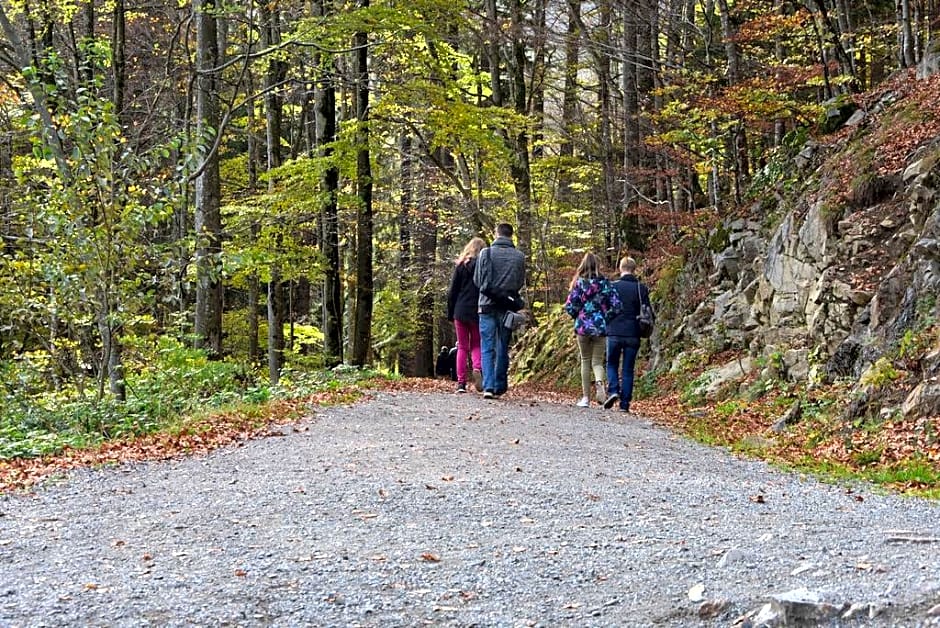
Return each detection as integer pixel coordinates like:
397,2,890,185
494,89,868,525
604,257,650,412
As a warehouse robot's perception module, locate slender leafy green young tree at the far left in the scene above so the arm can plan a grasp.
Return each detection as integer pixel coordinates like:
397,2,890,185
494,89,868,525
0,42,184,398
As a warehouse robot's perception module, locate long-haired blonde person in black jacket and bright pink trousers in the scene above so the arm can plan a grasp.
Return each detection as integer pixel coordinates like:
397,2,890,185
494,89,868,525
447,238,486,393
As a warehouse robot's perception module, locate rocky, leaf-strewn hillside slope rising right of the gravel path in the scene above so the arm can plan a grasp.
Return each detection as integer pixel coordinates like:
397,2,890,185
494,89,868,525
517,73,940,486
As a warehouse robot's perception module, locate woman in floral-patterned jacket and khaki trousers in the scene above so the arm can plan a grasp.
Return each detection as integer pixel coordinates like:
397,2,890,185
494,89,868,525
565,253,620,408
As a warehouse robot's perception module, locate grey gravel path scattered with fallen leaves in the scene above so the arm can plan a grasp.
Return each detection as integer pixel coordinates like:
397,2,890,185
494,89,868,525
0,393,940,627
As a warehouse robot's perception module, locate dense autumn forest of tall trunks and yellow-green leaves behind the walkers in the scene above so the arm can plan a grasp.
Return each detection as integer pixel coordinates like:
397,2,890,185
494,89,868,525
0,0,940,412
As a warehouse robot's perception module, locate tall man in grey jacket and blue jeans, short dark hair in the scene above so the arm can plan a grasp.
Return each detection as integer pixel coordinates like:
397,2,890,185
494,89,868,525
473,223,525,399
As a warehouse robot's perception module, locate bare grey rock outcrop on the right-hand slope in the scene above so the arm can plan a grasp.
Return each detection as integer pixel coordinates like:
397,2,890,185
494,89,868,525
670,130,940,416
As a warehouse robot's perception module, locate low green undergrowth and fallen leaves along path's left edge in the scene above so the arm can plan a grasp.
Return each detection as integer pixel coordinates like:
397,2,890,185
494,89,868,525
0,338,388,460
